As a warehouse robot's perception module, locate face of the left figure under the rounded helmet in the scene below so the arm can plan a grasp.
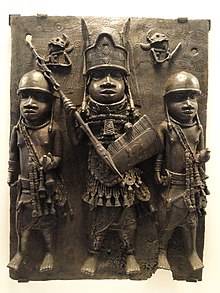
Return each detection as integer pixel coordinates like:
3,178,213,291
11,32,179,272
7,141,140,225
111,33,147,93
19,92,52,125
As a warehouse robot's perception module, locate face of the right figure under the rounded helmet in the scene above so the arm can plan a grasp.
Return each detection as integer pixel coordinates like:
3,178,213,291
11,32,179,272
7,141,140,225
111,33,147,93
166,91,198,123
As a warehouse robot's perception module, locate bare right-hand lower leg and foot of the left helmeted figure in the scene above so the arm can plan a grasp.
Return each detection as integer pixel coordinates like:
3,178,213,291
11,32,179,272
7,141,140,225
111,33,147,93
40,229,54,273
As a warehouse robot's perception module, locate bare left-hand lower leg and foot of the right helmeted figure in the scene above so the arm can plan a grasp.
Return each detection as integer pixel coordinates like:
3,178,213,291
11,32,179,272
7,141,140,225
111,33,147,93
157,229,174,270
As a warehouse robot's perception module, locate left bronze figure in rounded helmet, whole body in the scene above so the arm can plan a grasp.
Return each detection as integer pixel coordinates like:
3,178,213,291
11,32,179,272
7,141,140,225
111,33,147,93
8,70,70,272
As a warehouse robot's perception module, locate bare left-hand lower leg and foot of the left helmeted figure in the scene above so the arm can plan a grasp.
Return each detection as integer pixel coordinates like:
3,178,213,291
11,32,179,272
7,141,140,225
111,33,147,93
7,230,30,271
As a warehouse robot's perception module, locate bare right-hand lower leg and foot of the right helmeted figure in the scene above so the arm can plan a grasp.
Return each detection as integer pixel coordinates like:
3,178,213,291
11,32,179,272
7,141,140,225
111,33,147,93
183,216,204,271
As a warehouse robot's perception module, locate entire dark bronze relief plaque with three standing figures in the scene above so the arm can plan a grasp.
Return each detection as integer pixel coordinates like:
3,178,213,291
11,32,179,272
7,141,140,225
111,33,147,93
8,15,210,281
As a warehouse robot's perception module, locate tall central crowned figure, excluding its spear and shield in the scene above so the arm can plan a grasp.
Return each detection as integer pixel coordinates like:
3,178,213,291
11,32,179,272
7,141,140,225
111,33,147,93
67,24,153,275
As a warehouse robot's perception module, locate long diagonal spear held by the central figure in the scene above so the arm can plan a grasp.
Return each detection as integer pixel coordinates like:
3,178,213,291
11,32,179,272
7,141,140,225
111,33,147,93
26,34,122,178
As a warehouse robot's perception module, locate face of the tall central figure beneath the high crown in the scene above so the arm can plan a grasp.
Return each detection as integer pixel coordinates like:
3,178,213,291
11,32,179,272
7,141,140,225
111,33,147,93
88,69,125,104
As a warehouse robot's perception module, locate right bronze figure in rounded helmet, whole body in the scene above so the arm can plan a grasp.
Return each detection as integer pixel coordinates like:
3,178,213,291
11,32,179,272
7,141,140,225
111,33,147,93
155,71,210,270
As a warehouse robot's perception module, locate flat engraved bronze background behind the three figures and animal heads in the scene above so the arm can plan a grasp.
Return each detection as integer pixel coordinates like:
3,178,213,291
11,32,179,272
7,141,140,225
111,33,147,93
10,15,209,281
